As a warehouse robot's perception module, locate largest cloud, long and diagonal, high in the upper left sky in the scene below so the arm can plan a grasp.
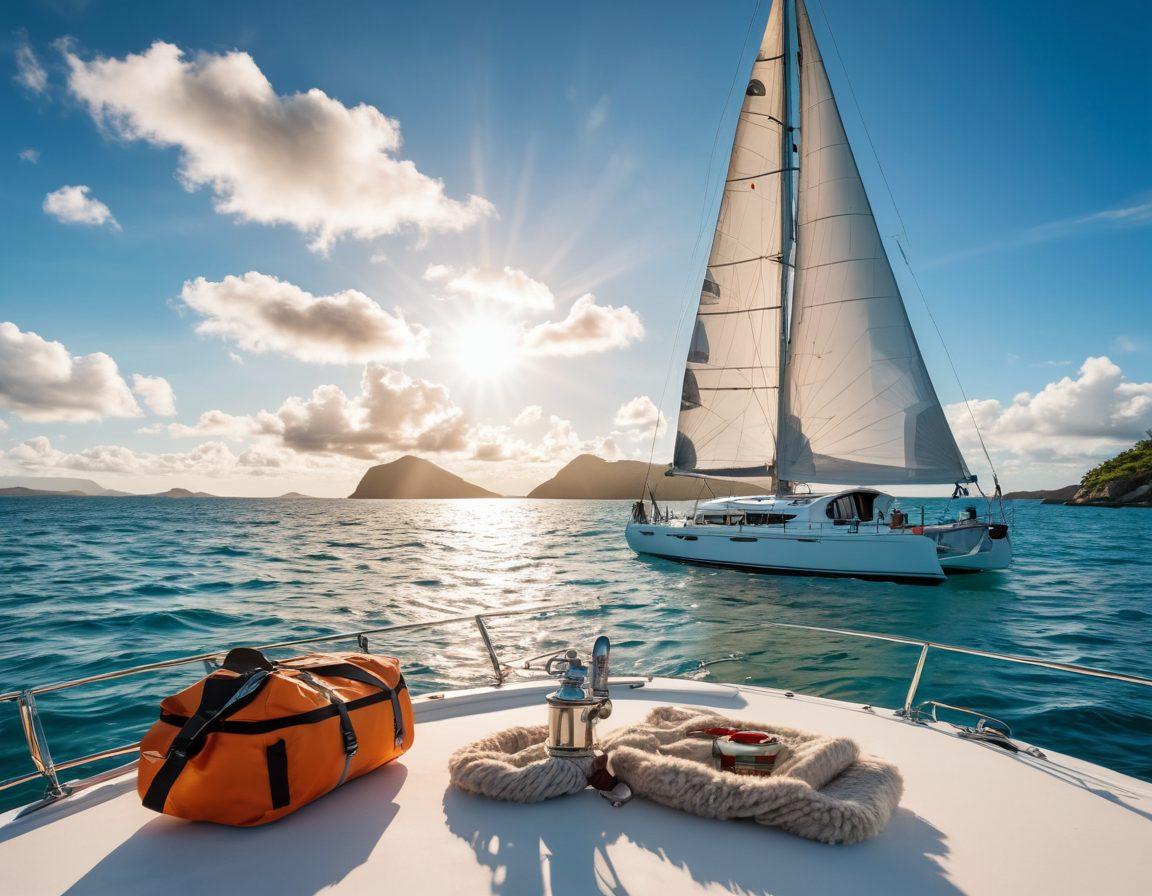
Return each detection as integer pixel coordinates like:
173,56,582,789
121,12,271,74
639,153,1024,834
65,41,493,252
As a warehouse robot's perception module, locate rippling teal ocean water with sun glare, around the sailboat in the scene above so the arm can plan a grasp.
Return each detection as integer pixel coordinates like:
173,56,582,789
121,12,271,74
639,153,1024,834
0,498,1152,807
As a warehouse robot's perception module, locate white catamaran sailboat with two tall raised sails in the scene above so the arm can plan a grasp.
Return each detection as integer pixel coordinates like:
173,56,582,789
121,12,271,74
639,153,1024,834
626,0,1011,582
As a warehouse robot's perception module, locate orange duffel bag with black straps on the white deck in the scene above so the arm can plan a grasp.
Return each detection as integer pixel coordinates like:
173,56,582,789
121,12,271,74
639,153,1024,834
136,647,414,825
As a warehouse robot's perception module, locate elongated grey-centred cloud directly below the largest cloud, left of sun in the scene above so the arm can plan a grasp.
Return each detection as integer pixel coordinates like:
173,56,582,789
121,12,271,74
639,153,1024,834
180,271,429,364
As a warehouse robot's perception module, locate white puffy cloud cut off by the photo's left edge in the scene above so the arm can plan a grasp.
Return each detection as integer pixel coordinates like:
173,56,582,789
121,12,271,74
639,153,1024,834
0,321,142,420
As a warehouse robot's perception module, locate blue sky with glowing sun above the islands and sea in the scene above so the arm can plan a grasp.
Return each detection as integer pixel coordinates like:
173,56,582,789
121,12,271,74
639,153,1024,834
0,0,1152,494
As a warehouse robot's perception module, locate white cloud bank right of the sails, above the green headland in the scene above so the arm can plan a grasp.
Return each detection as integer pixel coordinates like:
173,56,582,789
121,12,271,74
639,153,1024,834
946,357,1152,485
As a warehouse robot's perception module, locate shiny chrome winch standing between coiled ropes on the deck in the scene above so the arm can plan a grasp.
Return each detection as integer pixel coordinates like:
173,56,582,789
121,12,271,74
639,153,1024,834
544,635,612,759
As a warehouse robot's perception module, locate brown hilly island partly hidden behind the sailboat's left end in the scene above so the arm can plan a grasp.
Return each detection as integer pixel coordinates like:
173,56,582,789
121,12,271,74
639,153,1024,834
528,454,764,501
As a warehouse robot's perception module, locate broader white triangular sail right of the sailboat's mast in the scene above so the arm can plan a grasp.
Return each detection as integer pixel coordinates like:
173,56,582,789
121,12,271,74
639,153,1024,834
778,0,969,485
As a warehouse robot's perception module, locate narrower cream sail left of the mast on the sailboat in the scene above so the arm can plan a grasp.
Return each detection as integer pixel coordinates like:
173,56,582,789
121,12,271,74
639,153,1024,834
673,0,791,477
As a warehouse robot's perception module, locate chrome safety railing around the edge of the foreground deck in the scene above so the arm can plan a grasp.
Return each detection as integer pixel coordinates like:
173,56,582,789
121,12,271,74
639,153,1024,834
0,606,1152,802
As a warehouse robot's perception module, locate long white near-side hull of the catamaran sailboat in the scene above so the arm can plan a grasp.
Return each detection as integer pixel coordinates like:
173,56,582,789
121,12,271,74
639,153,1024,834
626,521,946,584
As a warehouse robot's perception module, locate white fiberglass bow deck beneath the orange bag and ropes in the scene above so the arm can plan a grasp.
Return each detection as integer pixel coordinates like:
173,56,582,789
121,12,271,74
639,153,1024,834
0,678,1152,896
